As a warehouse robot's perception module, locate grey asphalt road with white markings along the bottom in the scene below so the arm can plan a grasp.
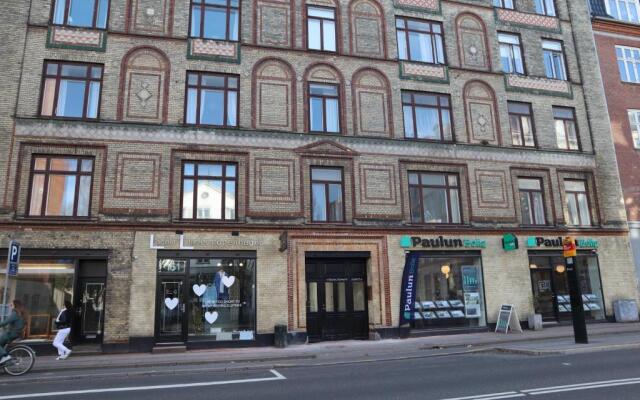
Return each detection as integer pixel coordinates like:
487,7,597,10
0,350,640,400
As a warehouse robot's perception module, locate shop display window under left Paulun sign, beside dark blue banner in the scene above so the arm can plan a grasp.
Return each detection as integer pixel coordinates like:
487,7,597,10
412,255,486,329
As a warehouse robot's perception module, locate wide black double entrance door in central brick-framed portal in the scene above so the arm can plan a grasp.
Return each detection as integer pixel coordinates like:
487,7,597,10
305,258,369,342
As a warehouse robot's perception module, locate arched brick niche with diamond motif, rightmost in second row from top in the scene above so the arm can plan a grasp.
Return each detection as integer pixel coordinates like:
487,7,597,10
464,80,500,145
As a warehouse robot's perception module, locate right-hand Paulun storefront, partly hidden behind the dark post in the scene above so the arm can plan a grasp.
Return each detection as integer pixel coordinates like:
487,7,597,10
527,237,605,322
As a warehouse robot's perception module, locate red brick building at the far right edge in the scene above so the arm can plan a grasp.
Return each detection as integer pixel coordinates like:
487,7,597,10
590,0,640,300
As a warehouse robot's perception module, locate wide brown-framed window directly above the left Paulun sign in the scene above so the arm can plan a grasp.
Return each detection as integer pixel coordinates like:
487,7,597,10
409,172,461,224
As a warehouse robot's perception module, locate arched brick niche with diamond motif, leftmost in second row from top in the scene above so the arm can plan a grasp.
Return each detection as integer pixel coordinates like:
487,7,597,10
118,47,171,123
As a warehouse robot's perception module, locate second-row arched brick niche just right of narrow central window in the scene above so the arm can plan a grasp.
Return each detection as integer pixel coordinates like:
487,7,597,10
351,68,393,136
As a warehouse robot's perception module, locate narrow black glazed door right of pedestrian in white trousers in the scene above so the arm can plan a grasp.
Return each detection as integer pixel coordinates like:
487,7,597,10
72,260,107,344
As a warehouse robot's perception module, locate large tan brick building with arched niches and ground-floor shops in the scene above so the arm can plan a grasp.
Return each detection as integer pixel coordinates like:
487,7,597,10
0,0,637,351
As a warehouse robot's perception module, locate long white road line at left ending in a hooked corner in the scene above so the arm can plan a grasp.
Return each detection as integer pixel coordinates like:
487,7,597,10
0,369,287,400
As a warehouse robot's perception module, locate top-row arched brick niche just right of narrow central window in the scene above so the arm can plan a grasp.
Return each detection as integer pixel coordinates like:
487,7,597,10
349,0,387,58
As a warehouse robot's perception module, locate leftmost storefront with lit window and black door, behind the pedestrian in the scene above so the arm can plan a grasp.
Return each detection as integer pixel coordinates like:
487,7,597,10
0,250,107,344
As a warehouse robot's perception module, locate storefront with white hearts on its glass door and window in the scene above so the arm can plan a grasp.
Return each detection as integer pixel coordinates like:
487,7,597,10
155,251,256,344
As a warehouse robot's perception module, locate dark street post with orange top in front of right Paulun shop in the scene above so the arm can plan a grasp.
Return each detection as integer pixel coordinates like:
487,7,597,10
562,236,589,344
